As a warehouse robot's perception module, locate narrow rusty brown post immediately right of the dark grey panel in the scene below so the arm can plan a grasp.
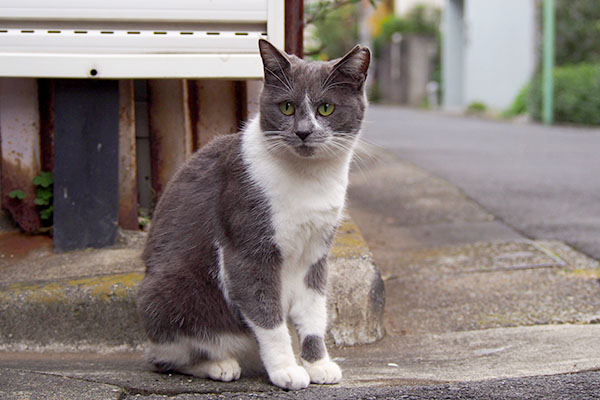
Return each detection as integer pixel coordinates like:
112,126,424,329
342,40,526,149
119,80,139,230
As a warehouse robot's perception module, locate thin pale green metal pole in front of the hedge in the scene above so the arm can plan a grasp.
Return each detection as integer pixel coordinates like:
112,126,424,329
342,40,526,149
542,0,555,125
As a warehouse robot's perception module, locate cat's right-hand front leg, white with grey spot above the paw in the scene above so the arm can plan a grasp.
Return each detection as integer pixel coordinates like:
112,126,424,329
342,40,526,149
290,258,342,384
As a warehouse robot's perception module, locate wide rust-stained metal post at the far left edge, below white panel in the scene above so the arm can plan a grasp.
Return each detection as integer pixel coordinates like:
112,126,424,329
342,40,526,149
0,78,42,232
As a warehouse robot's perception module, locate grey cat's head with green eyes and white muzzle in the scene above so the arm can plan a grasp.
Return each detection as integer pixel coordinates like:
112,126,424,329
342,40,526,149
259,39,371,158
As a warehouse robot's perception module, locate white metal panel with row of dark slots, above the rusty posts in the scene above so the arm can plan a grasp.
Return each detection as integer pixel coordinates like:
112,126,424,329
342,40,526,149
0,0,285,79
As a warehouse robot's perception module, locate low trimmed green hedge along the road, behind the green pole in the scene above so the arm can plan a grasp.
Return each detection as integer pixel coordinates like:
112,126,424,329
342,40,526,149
528,63,600,125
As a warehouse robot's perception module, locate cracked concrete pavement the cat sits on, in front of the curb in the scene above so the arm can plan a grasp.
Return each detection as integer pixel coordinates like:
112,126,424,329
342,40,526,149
0,142,600,399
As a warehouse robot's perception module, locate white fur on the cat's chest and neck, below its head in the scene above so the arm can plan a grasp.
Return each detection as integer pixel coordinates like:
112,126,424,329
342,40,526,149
243,120,351,270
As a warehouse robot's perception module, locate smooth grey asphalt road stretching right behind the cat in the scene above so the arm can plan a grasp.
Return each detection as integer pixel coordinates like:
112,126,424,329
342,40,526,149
363,106,600,259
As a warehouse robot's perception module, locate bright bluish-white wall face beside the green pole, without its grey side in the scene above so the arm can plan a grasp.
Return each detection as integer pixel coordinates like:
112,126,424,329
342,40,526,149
463,0,535,110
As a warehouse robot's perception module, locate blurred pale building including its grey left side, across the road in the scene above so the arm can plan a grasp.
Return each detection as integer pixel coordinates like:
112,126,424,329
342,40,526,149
442,0,536,110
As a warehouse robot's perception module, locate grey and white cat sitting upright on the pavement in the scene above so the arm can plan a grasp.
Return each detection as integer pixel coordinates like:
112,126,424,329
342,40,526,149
137,39,371,390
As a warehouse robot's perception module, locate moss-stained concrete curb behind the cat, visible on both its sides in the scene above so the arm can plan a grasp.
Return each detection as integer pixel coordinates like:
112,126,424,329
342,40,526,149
0,220,385,352
